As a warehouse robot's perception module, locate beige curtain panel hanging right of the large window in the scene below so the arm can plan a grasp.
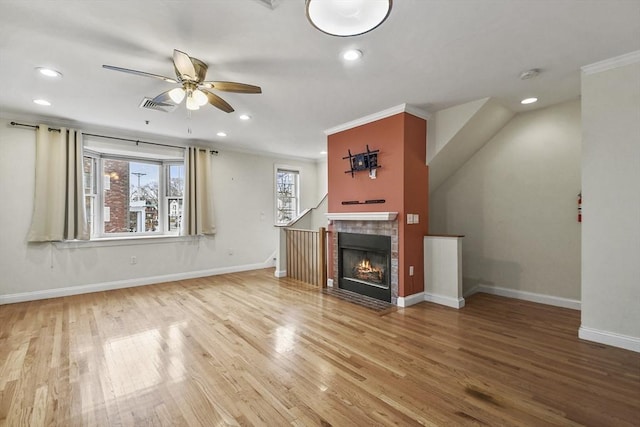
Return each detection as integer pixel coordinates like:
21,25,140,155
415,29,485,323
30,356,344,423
181,147,216,236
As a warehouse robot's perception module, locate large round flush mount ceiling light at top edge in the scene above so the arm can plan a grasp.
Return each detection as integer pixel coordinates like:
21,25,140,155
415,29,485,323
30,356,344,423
306,0,393,37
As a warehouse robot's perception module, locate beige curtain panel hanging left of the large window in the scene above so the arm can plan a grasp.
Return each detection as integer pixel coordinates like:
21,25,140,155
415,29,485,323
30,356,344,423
28,125,89,242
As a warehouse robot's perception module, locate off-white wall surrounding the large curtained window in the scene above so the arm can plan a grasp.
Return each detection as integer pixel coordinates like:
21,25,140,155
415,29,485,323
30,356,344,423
0,120,318,303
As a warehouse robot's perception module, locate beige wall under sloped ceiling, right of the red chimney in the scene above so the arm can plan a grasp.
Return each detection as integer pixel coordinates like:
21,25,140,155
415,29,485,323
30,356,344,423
429,101,581,306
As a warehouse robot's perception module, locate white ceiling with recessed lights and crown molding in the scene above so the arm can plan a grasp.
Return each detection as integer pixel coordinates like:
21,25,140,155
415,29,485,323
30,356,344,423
0,0,640,158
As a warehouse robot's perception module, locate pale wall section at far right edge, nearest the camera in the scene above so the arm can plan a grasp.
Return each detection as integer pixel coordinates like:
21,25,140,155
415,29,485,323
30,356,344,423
580,51,640,351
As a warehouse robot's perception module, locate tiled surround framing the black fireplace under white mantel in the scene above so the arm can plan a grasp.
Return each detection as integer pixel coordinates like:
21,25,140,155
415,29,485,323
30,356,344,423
331,219,398,305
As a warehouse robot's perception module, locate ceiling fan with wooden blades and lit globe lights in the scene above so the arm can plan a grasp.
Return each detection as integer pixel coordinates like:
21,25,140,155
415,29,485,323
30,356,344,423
102,49,262,113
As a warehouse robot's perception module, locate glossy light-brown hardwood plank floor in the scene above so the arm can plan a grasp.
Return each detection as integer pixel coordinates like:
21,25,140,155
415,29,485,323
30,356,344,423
0,270,640,426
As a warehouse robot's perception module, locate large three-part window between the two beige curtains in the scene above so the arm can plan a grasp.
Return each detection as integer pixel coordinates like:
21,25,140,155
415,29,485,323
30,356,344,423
84,144,184,239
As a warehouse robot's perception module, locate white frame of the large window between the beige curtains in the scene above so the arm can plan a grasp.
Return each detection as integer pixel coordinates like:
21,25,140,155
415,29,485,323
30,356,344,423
84,148,184,240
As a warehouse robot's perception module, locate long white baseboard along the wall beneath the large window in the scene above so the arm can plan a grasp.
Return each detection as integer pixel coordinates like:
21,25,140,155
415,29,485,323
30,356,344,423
0,263,271,305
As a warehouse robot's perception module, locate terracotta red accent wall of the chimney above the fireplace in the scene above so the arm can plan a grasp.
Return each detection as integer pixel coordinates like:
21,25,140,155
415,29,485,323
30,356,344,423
327,113,429,297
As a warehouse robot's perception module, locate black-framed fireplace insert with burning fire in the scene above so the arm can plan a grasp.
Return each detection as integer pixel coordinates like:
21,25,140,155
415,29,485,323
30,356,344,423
338,233,391,302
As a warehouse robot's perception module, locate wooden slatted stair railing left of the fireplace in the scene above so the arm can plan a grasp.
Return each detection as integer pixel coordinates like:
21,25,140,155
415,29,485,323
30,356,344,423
285,227,327,287
